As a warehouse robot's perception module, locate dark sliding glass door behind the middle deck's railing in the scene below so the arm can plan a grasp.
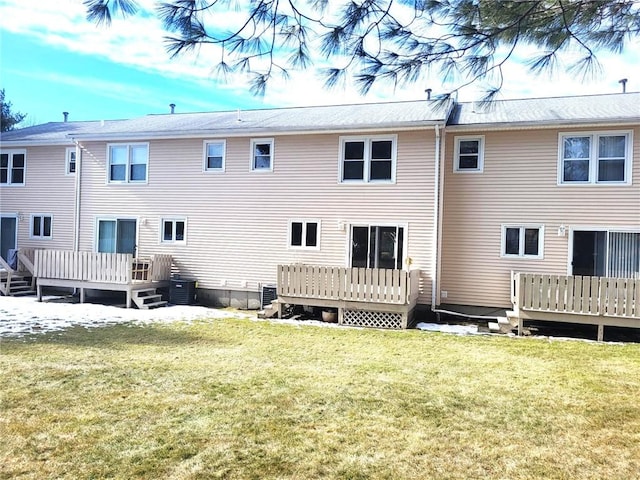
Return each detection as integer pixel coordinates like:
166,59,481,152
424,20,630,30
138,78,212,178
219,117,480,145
351,225,405,269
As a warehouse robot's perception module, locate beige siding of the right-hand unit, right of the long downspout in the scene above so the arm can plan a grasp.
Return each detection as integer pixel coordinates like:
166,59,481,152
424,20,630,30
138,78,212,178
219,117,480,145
440,126,640,307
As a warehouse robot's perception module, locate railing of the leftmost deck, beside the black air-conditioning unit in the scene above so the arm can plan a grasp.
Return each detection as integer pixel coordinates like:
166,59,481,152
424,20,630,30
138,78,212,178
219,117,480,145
33,250,171,284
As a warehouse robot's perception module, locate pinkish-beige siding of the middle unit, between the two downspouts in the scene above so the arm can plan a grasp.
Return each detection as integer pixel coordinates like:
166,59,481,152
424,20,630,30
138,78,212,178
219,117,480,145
74,129,435,303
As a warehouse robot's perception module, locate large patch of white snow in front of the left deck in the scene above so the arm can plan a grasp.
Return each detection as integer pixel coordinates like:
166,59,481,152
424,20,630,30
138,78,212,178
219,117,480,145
0,297,256,337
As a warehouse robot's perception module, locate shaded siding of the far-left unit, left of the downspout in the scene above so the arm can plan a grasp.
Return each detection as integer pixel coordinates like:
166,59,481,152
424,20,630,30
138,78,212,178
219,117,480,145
0,145,75,249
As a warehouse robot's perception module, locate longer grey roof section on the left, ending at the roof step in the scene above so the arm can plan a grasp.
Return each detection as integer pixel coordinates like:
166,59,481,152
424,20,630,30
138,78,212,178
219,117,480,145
2,100,451,143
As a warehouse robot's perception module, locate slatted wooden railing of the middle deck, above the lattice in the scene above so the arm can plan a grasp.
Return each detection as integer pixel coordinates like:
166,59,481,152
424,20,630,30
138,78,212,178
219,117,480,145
277,264,420,305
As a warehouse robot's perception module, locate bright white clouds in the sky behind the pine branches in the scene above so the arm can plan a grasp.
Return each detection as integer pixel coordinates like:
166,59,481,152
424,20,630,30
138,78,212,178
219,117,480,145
0,0,640,108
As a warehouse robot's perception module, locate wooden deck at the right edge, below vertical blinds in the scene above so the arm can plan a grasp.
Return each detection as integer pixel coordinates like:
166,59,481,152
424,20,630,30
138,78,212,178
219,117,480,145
512,273,640,340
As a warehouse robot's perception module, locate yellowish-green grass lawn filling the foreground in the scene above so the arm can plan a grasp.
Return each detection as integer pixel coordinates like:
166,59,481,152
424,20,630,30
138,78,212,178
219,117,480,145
0,319,640,480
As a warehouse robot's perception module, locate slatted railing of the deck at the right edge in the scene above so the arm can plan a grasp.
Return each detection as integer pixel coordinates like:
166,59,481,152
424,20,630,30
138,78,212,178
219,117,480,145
513,273,640,319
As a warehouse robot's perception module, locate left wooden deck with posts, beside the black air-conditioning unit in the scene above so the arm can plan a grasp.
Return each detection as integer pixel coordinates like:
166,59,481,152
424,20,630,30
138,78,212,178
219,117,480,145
33,250,171,308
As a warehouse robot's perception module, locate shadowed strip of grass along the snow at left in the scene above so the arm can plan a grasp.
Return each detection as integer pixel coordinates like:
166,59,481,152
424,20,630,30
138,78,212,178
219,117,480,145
8,324,227,349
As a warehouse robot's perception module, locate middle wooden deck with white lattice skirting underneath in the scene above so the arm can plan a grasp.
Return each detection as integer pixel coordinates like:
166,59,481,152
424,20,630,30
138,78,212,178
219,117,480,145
277,264,420,328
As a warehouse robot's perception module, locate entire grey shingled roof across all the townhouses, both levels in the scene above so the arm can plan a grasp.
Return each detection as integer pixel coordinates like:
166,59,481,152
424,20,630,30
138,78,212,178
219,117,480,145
0,93,640,145
